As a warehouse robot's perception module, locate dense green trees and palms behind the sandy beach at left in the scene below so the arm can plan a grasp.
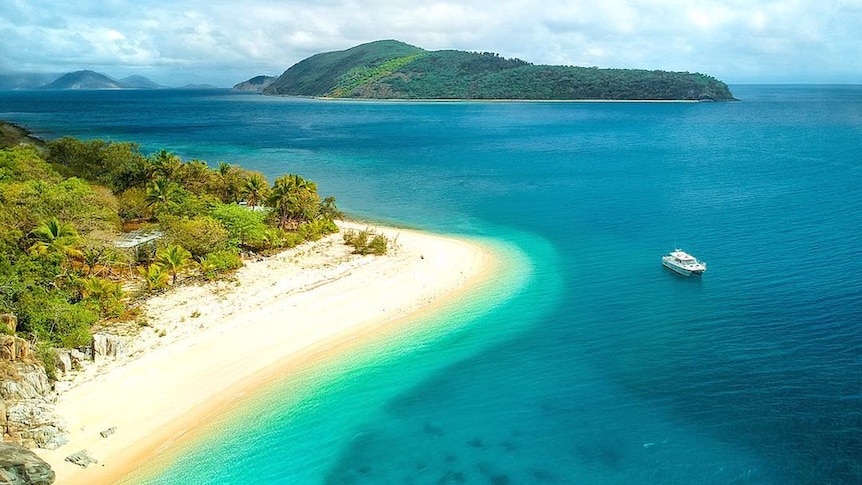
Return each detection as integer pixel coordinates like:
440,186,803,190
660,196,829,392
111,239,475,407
0,125,340,355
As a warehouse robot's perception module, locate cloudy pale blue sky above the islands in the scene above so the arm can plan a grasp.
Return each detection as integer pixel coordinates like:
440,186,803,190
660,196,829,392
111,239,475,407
0,0,862,87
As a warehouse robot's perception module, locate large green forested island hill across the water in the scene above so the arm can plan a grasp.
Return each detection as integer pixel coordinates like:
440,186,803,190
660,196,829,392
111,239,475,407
263,40,735,101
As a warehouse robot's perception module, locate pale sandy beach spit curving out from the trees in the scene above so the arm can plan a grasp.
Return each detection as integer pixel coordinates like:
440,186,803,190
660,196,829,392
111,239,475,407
36,224,499,485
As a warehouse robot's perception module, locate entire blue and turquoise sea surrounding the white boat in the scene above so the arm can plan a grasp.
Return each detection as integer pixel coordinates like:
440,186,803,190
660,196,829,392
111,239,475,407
0,85,862,485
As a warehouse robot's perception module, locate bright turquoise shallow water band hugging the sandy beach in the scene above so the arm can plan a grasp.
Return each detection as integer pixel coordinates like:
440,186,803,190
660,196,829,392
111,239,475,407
121,236,559,485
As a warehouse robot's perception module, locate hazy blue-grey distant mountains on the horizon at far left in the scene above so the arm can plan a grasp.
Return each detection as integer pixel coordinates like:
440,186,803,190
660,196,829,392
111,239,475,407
0,70,215,89
